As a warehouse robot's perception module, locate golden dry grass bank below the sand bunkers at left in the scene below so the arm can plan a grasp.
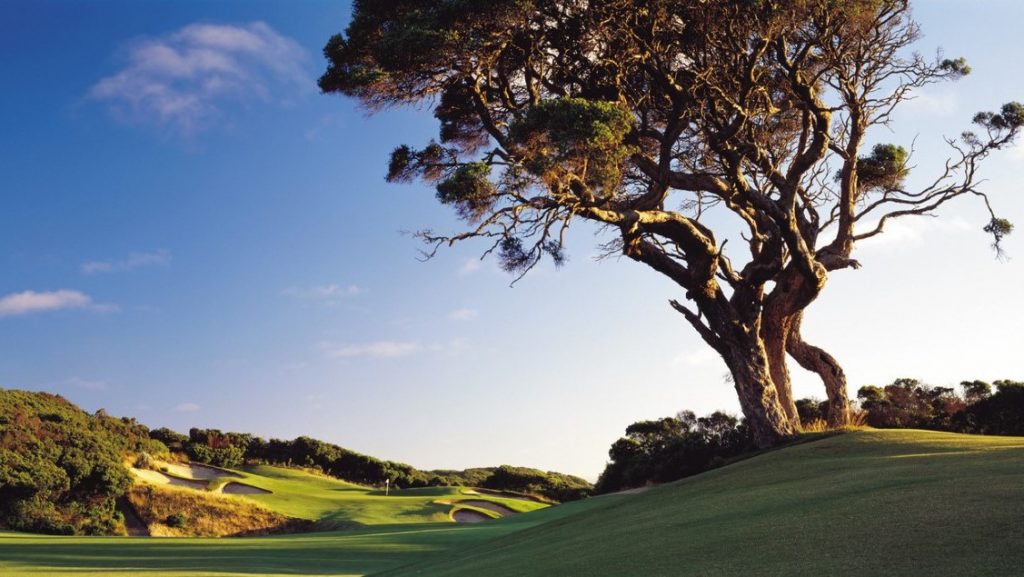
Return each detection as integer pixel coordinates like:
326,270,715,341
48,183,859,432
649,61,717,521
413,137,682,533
127,484,311,537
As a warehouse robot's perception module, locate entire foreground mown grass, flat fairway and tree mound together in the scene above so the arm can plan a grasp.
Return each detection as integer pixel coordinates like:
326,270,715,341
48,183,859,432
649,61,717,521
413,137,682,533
0,430,1024,577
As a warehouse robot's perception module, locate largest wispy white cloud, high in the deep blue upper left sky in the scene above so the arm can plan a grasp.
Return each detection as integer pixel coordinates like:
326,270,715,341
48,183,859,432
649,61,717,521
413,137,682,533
89,22,312,136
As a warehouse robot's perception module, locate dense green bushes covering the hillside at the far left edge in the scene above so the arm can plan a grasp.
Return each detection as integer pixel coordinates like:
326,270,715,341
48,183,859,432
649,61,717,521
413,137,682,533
0,389,167,535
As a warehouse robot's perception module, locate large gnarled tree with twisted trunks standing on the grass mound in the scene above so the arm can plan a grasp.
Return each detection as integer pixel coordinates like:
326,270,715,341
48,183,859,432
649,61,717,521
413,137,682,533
319,0,1024,446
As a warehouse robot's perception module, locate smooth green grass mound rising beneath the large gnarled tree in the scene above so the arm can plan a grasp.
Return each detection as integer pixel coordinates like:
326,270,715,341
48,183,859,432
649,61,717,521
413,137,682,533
385,430,1024,577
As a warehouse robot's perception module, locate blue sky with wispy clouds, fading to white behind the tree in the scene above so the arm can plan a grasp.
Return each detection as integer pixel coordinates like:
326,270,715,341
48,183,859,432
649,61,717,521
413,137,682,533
0,0,1024,478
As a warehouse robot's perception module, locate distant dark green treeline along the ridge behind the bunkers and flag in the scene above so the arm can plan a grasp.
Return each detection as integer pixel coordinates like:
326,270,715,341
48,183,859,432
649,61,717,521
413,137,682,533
150,428,593,501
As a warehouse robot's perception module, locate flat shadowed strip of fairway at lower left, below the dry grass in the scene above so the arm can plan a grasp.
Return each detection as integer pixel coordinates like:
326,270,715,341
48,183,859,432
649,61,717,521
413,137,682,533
0,497,622,577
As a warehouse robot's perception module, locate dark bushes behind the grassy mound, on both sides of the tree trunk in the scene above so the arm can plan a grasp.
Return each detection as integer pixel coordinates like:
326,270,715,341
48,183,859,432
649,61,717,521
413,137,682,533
595,378,1024,493
